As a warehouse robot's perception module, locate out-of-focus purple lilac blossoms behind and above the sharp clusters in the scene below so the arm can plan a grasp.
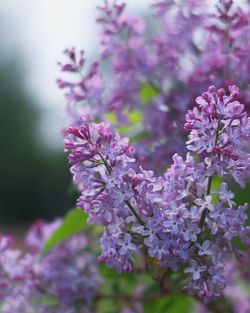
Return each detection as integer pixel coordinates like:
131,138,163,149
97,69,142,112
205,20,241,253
58,0,250,173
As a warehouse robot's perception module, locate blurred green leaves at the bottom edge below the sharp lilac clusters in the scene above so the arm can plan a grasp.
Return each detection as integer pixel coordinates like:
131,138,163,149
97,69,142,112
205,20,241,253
98,264,194,313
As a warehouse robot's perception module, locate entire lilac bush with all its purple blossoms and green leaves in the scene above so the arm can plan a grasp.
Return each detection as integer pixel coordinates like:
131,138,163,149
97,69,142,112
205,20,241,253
0,0,250,313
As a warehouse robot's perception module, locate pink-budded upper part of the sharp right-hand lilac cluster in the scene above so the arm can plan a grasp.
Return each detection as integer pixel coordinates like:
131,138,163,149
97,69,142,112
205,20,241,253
185,86,250,186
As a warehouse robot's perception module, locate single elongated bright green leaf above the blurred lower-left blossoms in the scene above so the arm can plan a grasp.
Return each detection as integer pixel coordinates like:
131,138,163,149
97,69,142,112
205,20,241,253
42,209,87,255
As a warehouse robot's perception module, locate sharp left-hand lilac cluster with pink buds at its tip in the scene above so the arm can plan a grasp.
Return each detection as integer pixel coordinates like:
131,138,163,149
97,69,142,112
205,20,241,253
65,116,150,272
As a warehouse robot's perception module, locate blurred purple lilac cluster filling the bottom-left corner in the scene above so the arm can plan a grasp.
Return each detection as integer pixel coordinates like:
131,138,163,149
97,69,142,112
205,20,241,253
0,220,101,313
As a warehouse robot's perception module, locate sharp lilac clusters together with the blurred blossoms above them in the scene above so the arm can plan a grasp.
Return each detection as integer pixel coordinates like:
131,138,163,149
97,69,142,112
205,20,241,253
59,0,250,303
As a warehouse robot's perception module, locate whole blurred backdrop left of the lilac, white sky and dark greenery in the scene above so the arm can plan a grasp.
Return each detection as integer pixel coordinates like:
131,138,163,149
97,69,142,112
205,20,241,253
0,0,151,233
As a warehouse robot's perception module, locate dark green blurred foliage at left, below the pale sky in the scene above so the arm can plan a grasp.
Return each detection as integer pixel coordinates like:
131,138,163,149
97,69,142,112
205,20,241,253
0,60,73,224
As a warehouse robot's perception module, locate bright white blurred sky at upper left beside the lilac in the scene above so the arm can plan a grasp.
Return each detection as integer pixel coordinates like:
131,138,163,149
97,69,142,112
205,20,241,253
0,0,148,147
